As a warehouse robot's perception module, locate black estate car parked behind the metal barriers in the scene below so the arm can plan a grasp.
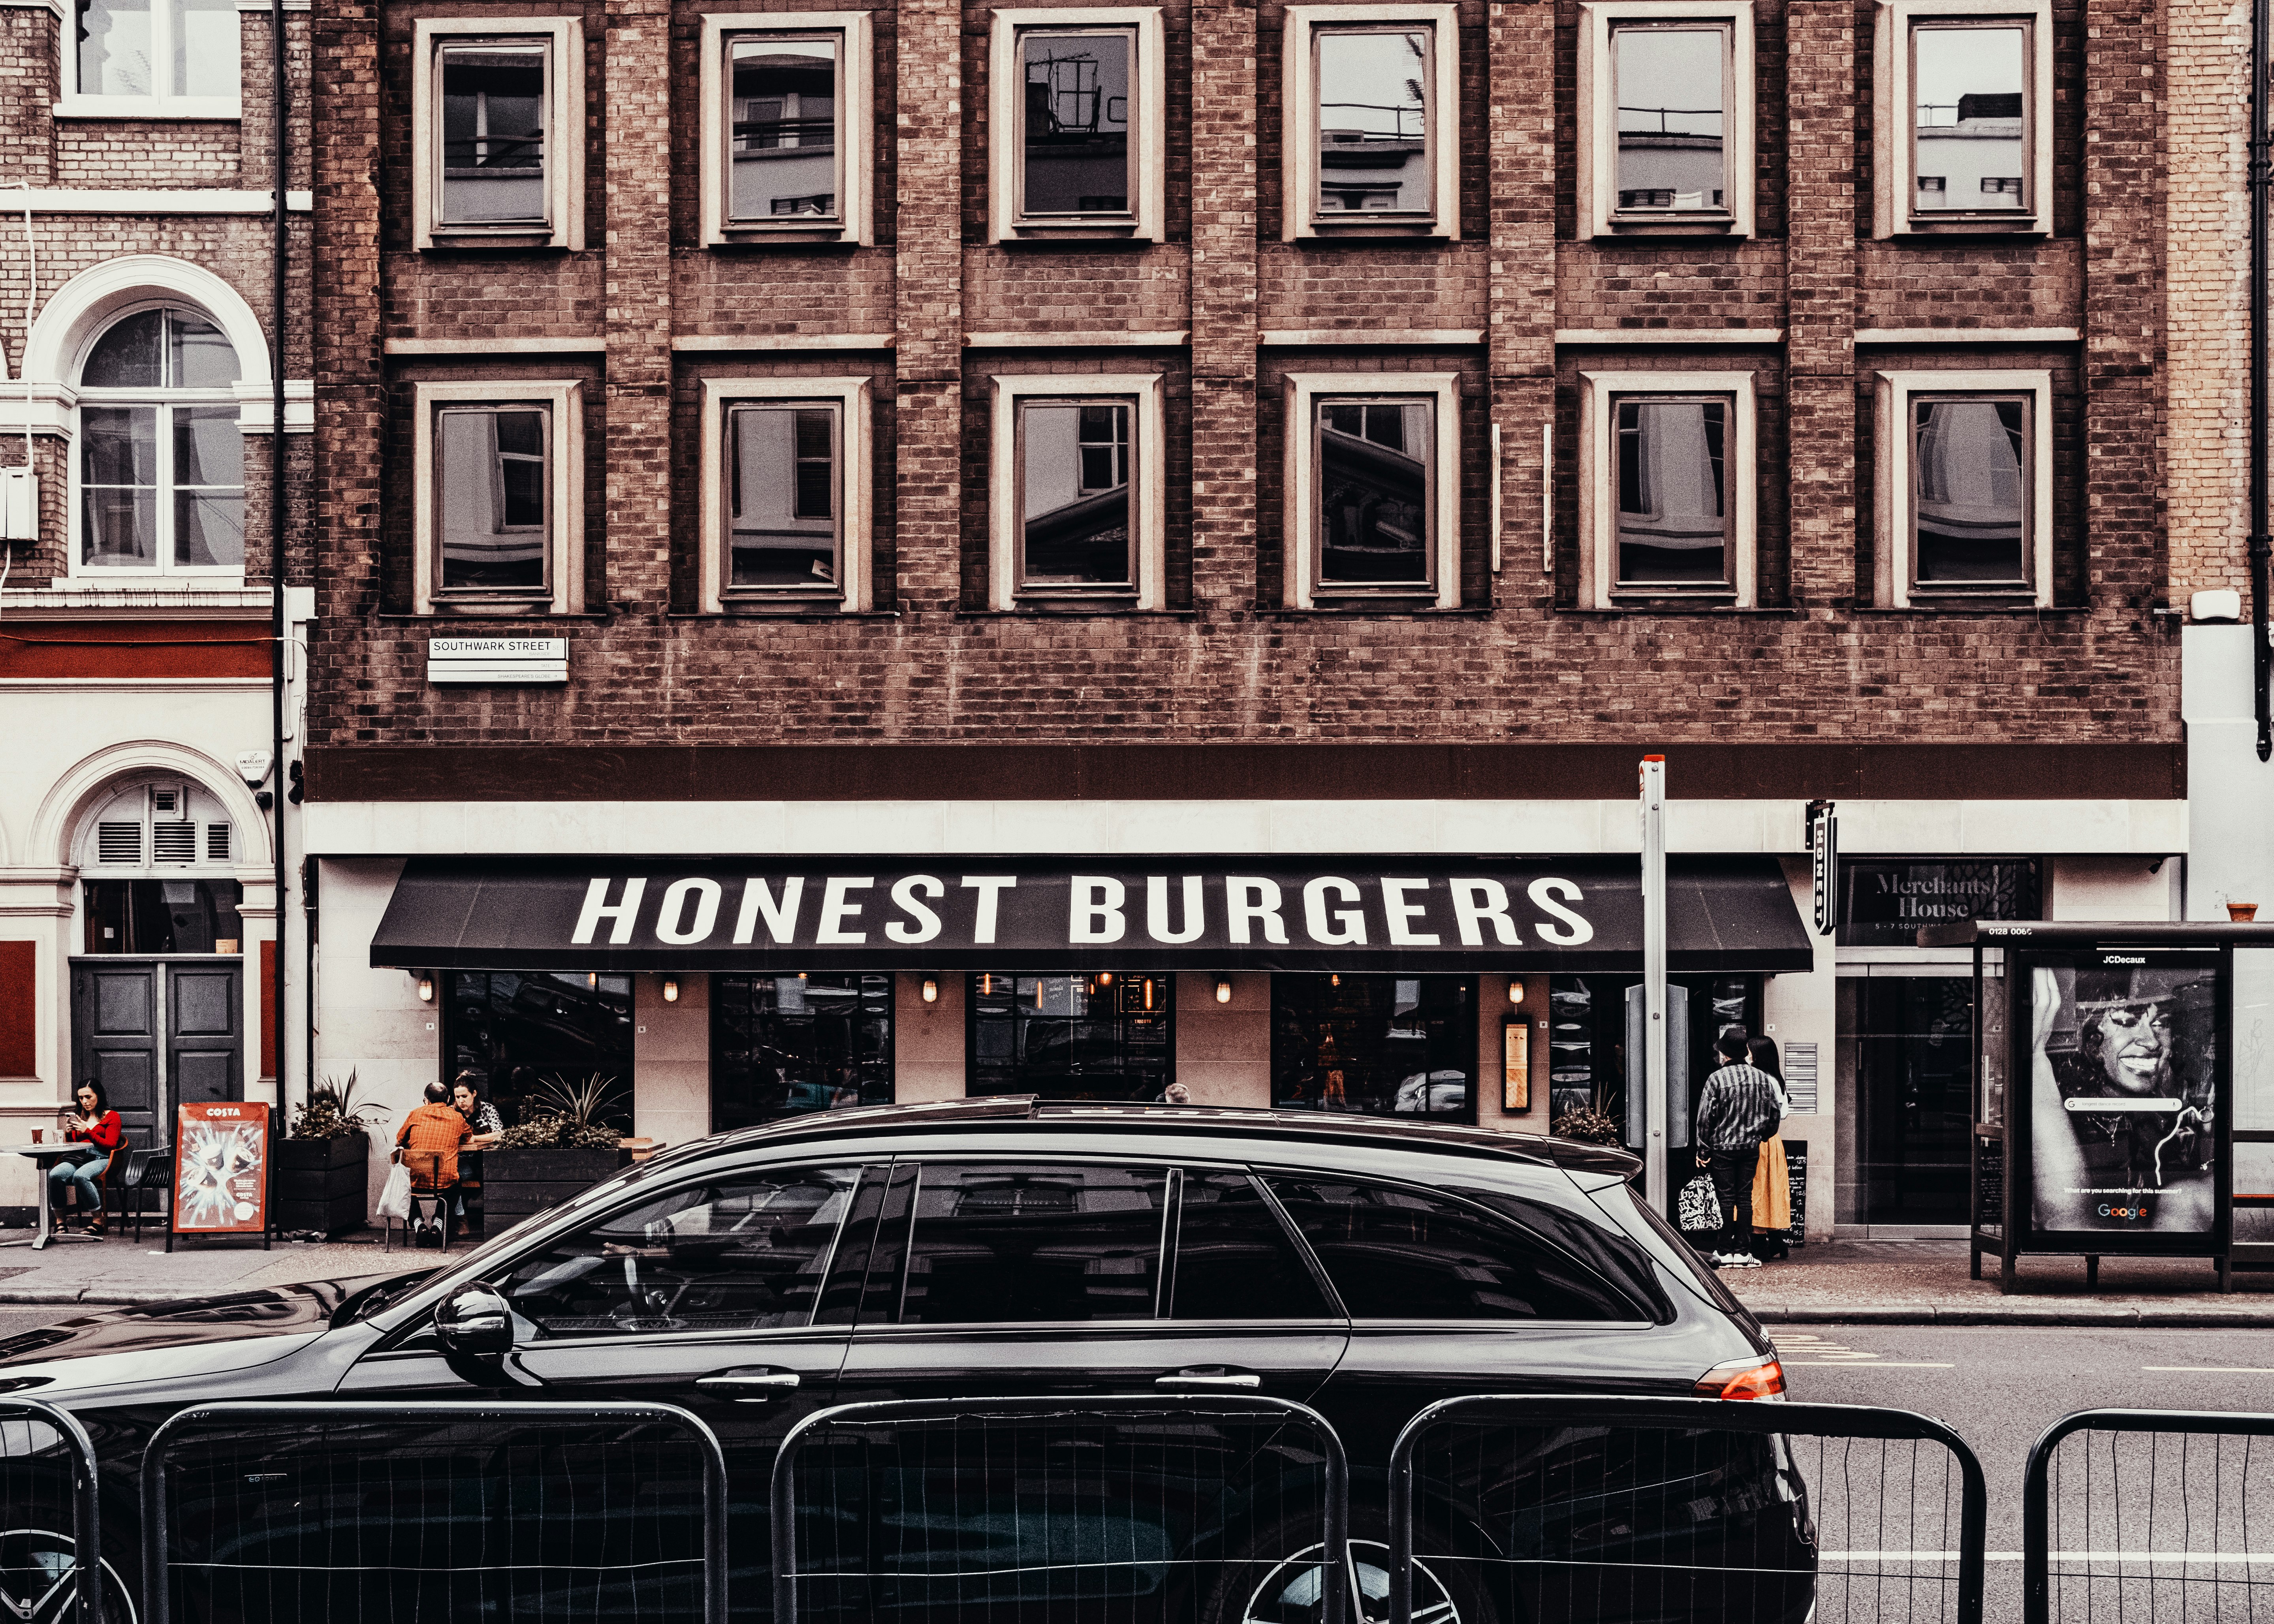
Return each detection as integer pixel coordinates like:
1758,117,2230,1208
0,1099,1812,1624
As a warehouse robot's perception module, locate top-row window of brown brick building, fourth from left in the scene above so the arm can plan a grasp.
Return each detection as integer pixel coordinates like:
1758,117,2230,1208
1283,5,1460,241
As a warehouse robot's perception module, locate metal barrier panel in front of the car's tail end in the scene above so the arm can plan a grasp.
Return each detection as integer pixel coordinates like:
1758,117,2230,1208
1390,1394,1990,1624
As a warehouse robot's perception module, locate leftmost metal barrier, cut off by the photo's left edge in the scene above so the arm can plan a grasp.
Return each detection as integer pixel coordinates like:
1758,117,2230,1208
0,1399,103,1624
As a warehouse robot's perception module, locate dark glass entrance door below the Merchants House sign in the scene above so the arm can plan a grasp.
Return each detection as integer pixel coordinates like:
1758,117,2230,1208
1840,971,1974,1226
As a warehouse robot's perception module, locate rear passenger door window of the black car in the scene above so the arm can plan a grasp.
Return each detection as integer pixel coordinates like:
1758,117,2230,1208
901,1162,1169,1326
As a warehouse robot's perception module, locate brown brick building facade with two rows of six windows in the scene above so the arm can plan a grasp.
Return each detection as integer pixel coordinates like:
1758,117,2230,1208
307,0,2201,1231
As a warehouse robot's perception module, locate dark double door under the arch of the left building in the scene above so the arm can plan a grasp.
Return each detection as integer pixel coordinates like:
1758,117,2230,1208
70,953,246,1147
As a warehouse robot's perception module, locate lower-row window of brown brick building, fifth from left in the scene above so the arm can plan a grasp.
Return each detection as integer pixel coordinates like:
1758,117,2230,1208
1580,373,1755,609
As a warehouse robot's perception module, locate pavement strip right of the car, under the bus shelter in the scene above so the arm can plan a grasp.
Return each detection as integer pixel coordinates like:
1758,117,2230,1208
1721,1240,2274,1328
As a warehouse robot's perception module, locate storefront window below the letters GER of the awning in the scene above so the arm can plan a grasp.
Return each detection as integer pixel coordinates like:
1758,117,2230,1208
1271,976,1476,1121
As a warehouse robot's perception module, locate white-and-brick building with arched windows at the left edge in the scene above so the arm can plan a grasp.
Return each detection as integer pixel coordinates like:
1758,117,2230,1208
0,0,314,1212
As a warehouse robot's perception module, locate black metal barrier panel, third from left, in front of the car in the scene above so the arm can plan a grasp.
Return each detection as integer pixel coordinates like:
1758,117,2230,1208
773,1394,1349,1624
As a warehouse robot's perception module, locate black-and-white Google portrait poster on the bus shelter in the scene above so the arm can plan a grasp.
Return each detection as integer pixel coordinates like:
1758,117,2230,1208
2028,949,2219,1235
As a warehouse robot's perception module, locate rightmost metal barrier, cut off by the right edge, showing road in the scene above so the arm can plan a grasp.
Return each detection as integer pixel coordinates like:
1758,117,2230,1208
2022,1410,2274,1624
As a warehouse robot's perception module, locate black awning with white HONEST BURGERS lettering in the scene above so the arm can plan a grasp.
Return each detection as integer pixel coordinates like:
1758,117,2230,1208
371,855,1815,974
